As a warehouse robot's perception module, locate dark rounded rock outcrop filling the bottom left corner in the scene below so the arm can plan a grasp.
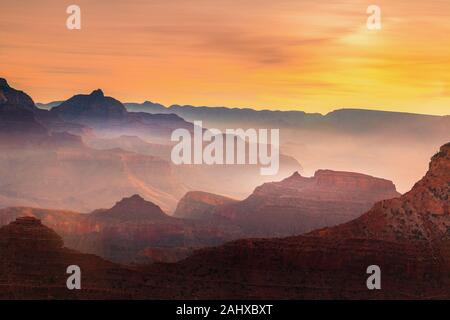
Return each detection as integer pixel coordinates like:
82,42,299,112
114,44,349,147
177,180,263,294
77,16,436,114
0,217,149,299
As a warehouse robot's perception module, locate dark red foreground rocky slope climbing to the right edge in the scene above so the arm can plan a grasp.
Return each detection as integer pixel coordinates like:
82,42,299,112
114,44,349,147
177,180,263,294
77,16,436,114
149,144,450,299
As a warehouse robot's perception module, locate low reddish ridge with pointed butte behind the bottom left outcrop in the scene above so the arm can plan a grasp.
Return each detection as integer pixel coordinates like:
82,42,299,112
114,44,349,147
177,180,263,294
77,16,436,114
0,195,244,264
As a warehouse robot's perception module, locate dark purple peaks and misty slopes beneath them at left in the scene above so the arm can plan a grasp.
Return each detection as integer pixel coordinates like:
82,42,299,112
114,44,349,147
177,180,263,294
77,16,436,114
0,79,301,213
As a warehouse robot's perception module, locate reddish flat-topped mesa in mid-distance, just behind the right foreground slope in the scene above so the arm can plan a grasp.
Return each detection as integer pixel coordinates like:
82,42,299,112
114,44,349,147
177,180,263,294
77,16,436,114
175,170,400,237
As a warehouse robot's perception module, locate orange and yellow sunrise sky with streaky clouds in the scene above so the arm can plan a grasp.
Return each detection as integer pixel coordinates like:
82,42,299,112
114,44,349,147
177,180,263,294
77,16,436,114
0,0,450,115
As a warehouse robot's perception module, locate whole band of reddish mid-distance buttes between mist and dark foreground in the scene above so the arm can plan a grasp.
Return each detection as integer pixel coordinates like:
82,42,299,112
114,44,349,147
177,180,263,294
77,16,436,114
0,171,399,264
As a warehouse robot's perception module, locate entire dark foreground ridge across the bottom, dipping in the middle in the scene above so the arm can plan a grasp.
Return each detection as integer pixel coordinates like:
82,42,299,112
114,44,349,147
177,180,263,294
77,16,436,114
0,143,450,299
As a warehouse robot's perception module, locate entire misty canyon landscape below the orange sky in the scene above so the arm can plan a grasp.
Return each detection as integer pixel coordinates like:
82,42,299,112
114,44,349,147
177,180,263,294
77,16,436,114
0,75,450,299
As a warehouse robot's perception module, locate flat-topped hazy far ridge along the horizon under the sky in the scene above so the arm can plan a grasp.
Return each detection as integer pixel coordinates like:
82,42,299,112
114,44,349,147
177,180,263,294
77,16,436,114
119,102,450,141
